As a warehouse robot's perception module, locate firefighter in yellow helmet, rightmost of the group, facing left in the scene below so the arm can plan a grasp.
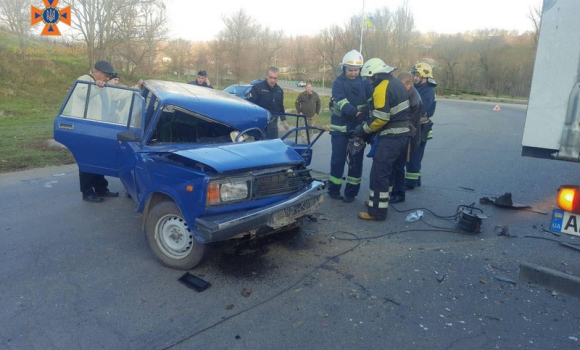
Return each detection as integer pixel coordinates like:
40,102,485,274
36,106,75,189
405,62,437,190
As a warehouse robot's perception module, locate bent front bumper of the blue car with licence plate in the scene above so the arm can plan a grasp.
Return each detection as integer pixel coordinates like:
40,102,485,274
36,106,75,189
195,181,324,243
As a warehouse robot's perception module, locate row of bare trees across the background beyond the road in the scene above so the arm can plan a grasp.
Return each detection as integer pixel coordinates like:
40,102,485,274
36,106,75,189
0,0,541,96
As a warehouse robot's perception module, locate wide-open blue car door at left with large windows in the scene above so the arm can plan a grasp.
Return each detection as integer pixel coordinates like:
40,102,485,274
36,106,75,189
54,80,144,177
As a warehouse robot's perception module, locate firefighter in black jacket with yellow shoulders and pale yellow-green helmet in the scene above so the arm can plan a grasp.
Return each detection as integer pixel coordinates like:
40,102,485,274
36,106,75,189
354,58,411,221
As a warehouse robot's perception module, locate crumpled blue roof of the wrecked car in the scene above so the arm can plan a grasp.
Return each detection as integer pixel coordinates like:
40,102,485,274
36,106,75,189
144,80,268,130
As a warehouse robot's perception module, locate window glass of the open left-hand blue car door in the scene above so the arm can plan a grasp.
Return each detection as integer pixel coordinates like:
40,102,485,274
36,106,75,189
62,81,141,125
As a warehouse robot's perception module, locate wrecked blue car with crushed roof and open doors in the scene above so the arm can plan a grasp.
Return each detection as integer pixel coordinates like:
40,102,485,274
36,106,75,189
54,80,324,270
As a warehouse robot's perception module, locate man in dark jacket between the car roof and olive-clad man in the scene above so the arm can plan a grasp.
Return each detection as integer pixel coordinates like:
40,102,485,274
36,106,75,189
248,67,290,140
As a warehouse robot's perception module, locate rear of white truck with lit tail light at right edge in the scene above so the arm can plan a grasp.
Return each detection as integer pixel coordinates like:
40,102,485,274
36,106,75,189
522,0,580,236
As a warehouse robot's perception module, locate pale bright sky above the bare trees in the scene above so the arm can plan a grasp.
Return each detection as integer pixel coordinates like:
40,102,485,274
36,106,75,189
166,0,542,41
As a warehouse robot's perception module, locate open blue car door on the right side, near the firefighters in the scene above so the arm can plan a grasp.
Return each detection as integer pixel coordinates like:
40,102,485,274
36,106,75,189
278,113,326,165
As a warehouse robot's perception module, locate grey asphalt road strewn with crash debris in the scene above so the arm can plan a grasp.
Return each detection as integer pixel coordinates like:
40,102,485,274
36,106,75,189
0,100,580,350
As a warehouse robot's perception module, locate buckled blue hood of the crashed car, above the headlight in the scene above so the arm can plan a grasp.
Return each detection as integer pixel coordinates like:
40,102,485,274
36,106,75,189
173,140,304,173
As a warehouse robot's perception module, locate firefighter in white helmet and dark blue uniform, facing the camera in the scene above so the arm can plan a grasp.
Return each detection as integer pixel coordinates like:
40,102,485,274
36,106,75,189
328,50,373,203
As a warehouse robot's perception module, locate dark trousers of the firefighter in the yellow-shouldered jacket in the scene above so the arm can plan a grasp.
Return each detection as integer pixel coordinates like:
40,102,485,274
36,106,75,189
368,136,409,220
